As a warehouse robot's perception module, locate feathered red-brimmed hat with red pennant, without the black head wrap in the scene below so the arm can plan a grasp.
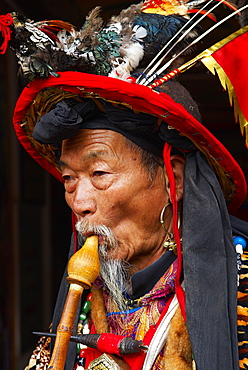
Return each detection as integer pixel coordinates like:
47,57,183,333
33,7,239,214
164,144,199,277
0,0,248,209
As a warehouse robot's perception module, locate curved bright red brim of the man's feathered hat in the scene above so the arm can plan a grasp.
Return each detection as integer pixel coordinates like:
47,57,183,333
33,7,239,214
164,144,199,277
13,72,247,212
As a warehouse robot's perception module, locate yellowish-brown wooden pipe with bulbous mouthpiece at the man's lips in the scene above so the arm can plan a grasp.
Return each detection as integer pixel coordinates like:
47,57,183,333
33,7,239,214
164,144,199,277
48,235,100,370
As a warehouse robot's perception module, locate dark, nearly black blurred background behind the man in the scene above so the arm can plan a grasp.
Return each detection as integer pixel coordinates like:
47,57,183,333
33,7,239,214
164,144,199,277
0,0,248,370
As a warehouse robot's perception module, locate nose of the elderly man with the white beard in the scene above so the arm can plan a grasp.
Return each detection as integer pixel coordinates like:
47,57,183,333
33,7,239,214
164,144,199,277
70,181,97,217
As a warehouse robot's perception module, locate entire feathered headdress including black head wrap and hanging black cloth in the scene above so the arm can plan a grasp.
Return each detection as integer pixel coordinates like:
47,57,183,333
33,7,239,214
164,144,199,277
0,0,248,369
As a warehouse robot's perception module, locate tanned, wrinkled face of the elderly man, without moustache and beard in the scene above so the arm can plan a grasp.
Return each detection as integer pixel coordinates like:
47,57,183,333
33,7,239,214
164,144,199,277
61,129,170,270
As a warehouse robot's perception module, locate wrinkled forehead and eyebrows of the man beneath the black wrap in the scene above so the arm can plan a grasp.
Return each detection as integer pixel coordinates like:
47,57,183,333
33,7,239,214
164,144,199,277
58,129,157,177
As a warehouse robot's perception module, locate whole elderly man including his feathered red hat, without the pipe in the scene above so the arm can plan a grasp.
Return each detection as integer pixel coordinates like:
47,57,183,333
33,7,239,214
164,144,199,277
2,1,248,370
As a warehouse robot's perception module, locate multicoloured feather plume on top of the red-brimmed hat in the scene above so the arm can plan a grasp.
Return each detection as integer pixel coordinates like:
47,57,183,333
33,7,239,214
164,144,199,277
0,0,243,82
